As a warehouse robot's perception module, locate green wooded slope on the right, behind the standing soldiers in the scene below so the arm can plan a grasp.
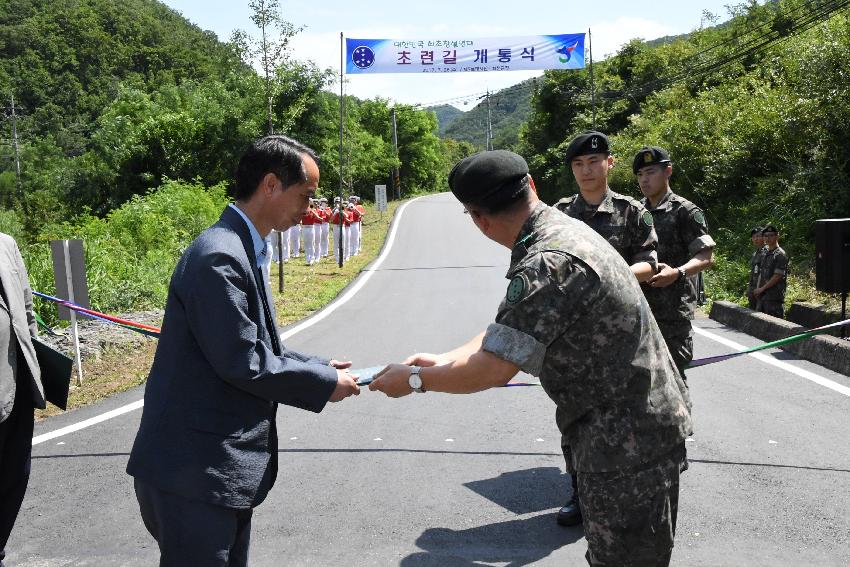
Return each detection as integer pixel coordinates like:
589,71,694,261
519,0,850,301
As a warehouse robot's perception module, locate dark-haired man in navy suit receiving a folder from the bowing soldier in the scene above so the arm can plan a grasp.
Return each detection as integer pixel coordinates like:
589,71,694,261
127,136,359,567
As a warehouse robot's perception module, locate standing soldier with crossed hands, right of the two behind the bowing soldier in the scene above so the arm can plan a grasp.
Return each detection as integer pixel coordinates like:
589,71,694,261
632,146,715,379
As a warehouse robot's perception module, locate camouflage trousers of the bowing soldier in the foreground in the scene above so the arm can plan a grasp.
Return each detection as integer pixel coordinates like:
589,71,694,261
578,443,685,567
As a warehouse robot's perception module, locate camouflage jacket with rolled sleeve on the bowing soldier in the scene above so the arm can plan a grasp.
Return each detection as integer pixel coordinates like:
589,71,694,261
482,203,691,472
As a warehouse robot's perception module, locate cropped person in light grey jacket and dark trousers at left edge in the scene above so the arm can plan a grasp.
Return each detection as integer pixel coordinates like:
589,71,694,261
0,233,45,567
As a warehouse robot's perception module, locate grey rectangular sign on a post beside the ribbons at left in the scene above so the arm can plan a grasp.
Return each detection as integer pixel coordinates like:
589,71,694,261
50,240,91,386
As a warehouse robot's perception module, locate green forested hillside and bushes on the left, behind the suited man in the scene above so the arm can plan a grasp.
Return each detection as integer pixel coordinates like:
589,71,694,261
0,0,464,320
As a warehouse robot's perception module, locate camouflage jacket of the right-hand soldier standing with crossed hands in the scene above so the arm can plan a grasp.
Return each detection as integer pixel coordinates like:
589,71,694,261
641,191,715,326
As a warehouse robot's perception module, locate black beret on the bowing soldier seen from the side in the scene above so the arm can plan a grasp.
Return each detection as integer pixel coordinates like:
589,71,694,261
449,150,528,204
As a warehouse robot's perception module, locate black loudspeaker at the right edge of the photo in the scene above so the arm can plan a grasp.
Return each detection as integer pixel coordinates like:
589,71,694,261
815,219,850,293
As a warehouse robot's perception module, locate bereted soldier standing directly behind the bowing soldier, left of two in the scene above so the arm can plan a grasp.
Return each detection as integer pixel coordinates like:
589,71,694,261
555,130,658,526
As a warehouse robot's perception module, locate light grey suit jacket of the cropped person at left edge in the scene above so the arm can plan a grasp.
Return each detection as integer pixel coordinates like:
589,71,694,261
0,233,45,422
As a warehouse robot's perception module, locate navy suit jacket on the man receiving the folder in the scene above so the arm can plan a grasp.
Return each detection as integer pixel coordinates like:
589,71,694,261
127,207,337,508
